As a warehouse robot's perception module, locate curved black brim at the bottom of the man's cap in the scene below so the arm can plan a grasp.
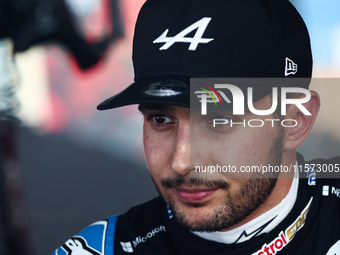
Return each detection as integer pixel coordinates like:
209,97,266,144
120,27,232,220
97,76,310,110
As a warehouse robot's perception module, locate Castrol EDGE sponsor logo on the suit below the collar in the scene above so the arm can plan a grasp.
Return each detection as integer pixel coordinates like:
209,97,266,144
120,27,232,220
252,197,313,255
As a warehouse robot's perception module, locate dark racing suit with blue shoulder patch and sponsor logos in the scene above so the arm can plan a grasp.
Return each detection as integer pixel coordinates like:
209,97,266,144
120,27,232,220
53,154,340,255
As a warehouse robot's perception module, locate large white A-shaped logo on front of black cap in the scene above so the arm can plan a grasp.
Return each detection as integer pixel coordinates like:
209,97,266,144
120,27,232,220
153,17,214,51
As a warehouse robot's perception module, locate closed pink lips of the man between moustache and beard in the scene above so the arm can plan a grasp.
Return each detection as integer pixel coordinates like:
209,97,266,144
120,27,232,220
175,189,217,203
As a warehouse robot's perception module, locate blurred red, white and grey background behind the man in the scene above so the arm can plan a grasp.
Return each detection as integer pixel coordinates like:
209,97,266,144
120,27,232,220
0,0,340,255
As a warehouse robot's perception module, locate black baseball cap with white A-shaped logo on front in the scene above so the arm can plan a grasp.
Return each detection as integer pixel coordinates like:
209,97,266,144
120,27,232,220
97,0,312,110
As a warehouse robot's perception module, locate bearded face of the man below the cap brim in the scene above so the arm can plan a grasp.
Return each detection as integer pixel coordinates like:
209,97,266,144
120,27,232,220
140,96,283,231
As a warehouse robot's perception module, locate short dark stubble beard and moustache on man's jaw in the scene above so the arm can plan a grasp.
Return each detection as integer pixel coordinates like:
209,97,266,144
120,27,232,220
154,128,283,232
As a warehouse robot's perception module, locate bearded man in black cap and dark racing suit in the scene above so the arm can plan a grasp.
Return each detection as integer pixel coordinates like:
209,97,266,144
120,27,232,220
55,0,340,255
